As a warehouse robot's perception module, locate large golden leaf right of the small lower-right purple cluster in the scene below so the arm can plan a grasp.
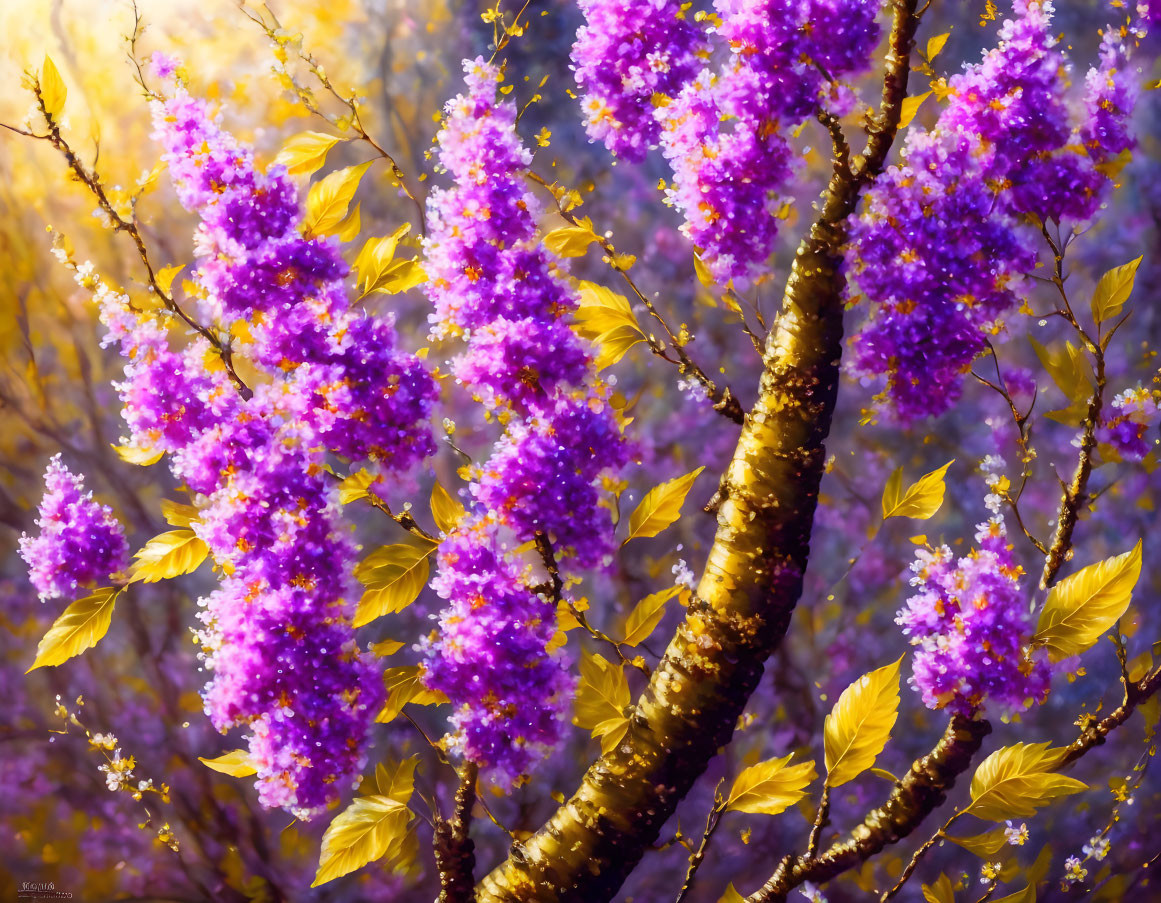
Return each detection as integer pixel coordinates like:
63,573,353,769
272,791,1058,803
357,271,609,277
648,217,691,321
1032,540,1141,662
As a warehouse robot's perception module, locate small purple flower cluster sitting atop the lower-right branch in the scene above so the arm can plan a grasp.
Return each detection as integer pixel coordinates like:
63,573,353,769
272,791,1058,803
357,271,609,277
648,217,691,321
895,499,1051,715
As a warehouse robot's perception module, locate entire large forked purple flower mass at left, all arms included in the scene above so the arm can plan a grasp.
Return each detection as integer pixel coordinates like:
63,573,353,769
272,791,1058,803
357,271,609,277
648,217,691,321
47,66,437,818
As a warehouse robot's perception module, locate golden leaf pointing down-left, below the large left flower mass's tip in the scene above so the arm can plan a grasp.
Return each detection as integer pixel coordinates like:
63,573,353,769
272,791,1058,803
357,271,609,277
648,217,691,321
311,795,411,887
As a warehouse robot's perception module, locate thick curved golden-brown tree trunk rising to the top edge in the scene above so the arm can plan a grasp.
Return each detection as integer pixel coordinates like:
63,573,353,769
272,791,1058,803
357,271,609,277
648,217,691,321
477,0,917,903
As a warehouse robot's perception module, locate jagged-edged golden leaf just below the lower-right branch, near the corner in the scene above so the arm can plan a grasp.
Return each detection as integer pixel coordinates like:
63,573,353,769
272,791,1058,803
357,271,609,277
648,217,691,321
964,743,1088,822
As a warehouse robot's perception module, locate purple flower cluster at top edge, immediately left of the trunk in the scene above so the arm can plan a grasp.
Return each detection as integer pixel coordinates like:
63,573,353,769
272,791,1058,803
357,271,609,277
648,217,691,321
656,0,879,284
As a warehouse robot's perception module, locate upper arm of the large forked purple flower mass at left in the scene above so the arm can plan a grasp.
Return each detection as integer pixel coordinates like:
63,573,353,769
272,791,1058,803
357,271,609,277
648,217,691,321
153,87,438,468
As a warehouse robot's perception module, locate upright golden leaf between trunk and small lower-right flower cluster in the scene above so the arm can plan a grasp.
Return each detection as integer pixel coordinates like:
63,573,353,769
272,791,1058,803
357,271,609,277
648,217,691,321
822,656,903,787
